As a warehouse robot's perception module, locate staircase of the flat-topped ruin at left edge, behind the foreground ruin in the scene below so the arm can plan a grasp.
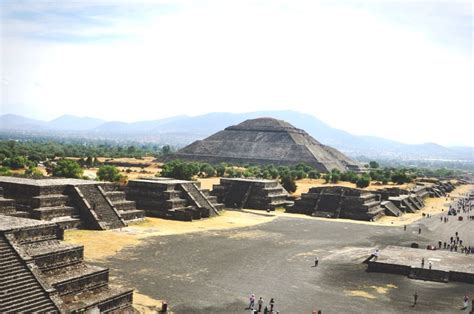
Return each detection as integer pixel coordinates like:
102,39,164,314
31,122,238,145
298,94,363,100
76,184,126,230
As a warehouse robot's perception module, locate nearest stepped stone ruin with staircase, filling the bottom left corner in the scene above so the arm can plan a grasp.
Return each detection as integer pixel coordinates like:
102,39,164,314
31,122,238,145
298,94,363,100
0,216,134,313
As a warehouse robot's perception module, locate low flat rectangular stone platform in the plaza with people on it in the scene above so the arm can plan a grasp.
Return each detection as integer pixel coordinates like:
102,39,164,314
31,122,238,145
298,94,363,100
367,246,474,284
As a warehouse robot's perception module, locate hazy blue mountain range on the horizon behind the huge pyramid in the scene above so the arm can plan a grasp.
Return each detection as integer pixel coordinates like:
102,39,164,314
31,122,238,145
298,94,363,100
0,111,474,162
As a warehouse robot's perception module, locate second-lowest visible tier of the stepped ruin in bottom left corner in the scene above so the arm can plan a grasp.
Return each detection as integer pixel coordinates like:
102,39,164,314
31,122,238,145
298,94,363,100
43,264,109,295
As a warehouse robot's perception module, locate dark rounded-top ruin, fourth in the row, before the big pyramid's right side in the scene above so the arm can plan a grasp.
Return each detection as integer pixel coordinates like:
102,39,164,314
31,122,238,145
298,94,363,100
287,186,385,221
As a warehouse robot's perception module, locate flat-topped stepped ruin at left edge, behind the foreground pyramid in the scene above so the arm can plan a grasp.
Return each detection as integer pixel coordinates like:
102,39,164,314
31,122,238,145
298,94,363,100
0,177,145,230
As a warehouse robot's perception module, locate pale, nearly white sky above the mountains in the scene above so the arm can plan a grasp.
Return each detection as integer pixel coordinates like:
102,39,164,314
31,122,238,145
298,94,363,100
0,0,474,146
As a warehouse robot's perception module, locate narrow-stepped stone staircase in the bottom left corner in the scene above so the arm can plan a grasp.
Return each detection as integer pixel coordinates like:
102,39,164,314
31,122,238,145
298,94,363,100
0,234,58,313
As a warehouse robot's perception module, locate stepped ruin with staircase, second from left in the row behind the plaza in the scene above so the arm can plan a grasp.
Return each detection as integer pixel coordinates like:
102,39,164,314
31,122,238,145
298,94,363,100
126,178,223,221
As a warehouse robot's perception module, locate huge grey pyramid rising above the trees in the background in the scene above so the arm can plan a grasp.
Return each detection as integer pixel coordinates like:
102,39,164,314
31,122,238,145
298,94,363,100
174,118,361,172
